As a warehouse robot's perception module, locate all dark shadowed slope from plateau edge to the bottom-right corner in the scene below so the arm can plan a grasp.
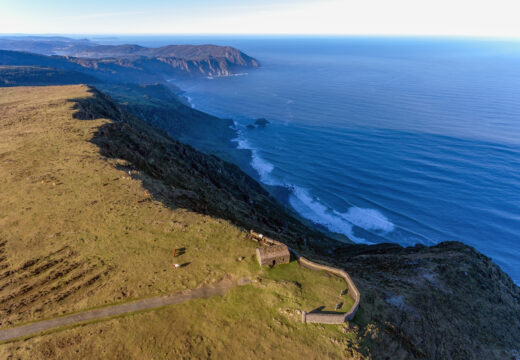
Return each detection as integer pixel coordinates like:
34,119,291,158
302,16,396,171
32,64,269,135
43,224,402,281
64,89,520,359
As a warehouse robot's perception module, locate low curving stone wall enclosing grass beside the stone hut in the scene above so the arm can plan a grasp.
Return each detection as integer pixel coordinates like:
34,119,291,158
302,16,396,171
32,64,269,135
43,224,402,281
251,231,361,324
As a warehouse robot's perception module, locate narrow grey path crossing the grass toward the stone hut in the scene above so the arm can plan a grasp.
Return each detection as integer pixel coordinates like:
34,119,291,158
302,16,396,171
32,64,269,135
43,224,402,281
0,279,249,342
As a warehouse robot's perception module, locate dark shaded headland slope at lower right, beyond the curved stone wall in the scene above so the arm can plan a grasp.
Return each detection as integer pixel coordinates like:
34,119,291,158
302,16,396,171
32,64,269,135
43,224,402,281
323,242,520,360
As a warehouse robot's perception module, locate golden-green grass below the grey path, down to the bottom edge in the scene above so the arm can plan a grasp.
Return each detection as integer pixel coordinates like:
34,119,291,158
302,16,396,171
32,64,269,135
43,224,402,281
0,285,357,359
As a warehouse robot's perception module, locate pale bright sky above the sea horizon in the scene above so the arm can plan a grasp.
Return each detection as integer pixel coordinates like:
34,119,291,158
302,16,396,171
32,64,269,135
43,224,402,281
0,0,520,38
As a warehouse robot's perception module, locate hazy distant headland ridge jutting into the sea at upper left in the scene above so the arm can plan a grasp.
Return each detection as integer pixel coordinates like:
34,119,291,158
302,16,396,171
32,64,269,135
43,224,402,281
0,37,260,78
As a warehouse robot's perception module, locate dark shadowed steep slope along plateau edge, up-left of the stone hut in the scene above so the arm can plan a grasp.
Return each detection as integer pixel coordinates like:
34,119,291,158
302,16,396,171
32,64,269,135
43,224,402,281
71,88,338,252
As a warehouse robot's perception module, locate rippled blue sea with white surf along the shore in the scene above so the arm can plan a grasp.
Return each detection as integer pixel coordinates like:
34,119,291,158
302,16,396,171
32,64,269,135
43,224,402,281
100,36,520,283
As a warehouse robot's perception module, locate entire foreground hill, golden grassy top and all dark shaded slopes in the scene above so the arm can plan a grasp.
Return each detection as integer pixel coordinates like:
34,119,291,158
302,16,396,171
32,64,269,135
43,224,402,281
0,86,520,360
